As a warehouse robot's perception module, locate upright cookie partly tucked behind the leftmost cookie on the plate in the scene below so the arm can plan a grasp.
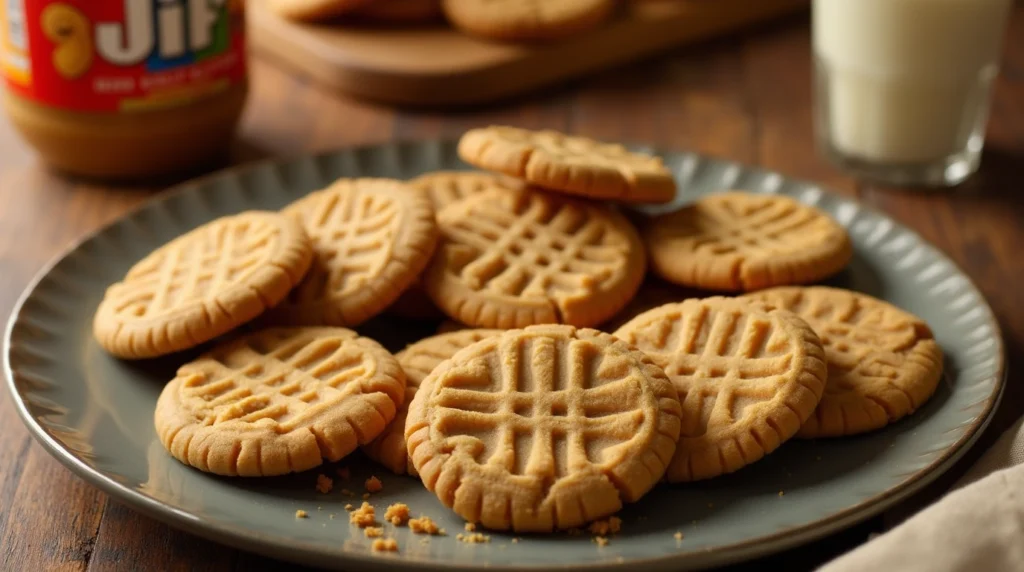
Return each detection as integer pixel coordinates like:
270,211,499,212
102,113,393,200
271,179,437,325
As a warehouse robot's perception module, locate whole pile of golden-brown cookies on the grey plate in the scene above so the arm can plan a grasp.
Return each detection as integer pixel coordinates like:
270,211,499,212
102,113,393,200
94,127,942,532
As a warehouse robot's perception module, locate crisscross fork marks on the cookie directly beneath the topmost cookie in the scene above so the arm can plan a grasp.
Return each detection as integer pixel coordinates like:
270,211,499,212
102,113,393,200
445,200,621,296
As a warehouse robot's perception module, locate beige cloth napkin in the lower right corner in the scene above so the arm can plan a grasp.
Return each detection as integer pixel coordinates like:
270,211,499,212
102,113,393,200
820,420,1024,572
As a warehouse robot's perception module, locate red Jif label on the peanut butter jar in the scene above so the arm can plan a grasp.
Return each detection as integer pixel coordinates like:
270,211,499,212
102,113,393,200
0,0,246,113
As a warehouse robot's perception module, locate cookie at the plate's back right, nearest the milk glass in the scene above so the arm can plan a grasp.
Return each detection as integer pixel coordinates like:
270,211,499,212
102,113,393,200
644,191,853,292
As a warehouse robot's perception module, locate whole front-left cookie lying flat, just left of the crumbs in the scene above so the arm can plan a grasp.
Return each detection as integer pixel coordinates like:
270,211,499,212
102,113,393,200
154,327,406,477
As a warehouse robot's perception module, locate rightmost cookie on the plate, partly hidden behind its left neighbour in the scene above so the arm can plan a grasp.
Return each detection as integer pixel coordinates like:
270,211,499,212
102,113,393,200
748,287,942,438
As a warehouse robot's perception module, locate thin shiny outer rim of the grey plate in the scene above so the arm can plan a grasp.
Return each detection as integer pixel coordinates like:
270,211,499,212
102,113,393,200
2,137,1008,572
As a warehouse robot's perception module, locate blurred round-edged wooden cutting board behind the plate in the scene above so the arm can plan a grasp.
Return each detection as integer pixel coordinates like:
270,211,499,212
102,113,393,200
249,0,808,106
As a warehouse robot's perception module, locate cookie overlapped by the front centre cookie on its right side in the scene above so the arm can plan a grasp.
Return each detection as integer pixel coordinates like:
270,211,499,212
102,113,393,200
615,298,826,482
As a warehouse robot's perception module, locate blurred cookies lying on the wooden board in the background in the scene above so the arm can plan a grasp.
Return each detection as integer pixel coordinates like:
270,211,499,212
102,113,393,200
269,0,617,42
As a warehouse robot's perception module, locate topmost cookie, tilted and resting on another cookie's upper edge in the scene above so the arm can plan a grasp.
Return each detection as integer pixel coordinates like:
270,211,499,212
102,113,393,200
459,126,676,203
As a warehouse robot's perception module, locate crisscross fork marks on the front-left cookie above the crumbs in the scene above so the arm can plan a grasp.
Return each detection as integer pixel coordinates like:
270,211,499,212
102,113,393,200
184,339,371,431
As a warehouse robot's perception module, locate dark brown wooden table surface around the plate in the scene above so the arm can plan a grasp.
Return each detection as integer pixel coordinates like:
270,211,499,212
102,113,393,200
0,4,1024,570
